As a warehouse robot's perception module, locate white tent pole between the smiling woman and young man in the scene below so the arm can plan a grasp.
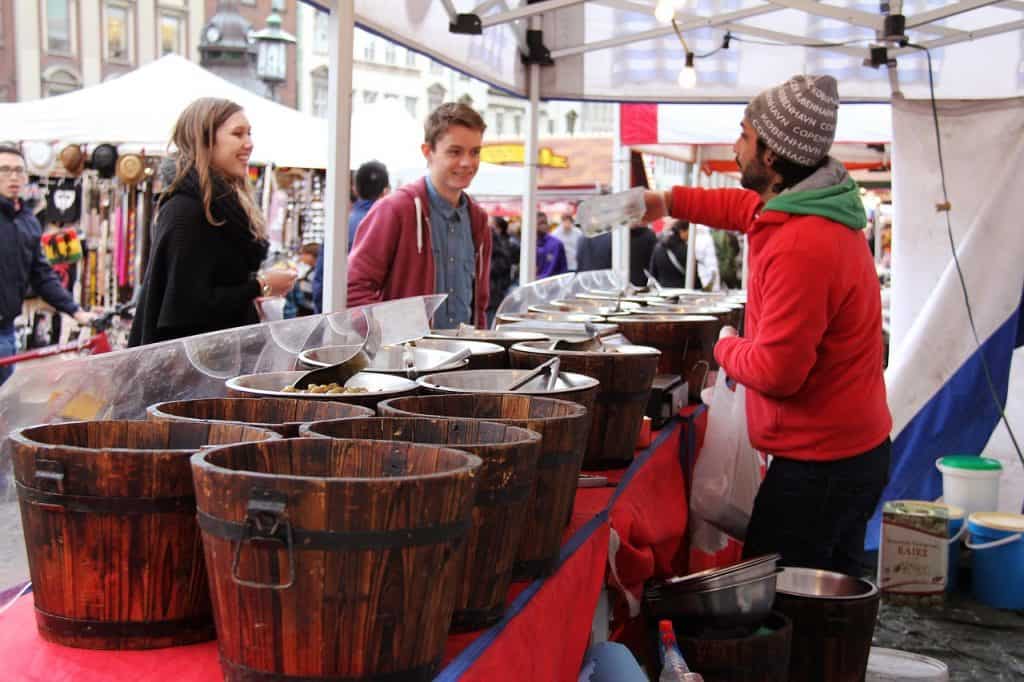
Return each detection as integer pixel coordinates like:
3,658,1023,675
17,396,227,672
323,2,355,312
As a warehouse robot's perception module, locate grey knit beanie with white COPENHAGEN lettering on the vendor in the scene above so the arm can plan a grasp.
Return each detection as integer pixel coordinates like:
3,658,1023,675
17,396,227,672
745,76,839,166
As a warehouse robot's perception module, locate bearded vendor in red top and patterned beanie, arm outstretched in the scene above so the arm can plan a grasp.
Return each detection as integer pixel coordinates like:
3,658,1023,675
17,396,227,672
645,76,892,573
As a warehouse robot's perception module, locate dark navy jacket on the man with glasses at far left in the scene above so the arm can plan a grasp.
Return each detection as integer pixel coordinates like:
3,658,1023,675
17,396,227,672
0,197,78,328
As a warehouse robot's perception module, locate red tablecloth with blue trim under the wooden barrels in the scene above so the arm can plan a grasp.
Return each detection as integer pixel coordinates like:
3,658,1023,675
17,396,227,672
0,414,720,682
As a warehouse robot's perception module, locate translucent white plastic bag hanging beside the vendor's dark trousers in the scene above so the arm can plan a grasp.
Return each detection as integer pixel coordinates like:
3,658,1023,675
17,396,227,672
690,371,761,541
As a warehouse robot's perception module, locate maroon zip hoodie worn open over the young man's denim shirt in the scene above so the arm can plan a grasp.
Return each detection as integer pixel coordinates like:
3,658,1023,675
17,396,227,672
348,177,490,328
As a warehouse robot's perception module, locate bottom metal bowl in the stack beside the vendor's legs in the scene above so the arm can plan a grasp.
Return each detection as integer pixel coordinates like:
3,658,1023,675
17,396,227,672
648,569,781,628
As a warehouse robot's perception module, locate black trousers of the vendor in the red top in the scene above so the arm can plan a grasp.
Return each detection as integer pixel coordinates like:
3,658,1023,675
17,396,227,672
743,438,892,576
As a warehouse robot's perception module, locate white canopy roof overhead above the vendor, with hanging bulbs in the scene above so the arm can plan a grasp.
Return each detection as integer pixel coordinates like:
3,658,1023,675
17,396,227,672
331,0,1024,102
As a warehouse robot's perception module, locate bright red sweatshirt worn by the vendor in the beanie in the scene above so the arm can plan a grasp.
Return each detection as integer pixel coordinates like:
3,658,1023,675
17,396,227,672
672,178,892,461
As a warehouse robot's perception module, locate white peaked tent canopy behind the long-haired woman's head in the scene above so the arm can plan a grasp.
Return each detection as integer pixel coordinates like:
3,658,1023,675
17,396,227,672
0,54,328,168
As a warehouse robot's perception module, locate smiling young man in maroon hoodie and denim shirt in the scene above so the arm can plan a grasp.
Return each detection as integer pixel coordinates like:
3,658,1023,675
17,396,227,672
348,102,492,328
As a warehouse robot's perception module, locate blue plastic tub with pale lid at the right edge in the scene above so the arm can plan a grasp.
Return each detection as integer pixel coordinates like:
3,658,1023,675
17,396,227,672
967,512,1024,609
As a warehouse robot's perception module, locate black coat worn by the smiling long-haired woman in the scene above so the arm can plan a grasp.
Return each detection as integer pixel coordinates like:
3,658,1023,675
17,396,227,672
128,171,267,346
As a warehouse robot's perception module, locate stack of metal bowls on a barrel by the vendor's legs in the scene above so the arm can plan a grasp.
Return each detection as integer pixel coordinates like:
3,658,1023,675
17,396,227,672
644,554,781,629
